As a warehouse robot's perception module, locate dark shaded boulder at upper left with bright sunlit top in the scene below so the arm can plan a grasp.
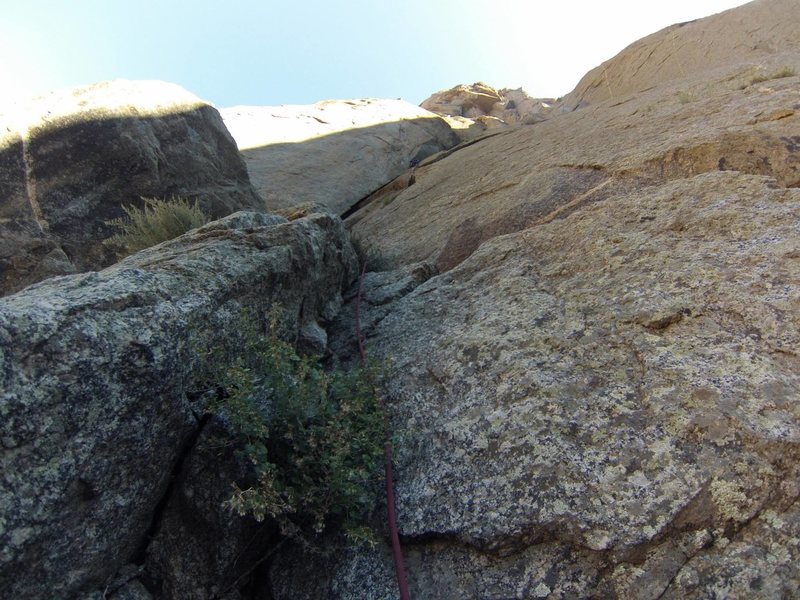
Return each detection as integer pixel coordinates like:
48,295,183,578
0,81,261,294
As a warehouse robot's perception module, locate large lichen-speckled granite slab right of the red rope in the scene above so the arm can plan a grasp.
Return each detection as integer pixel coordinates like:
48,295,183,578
274,172,800,599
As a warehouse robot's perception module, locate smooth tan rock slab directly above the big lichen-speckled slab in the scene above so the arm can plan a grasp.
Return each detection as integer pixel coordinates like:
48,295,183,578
348,51,800,270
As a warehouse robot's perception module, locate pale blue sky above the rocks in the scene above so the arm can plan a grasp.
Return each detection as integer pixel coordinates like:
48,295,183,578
0,0,746,107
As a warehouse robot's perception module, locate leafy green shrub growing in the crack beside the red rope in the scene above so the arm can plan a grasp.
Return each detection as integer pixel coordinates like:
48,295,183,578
202,312,384,541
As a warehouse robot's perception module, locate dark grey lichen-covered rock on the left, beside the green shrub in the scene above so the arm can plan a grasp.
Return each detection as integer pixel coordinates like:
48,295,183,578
0,207,356,599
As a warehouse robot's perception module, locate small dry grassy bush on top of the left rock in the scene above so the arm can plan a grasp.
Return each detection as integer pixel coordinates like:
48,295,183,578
106,198,209,255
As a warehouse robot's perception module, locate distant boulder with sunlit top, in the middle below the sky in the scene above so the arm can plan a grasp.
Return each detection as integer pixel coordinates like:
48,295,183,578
221,99,459,214
